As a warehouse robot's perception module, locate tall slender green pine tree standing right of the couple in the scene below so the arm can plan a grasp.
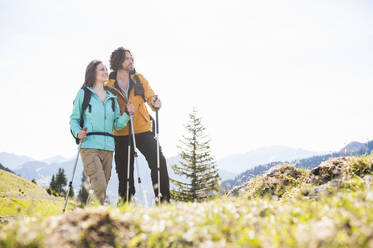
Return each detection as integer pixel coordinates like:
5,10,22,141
171,109,220,201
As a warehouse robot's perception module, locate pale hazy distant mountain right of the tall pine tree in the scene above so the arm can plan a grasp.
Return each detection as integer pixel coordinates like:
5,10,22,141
217,146,319,174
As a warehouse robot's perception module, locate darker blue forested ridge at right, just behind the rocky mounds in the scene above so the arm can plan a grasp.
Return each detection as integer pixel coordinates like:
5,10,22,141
222,141,373,189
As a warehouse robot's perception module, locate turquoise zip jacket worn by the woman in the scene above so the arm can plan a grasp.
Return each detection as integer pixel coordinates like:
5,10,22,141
70,87,130,151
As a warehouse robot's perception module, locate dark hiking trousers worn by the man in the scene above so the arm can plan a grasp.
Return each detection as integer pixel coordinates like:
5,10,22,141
114,131,170,202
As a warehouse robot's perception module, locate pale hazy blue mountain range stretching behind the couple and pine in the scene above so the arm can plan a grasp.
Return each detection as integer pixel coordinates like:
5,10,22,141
0,146,324,204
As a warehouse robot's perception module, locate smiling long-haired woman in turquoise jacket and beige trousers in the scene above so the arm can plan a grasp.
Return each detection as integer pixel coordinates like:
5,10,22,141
70,60,135,204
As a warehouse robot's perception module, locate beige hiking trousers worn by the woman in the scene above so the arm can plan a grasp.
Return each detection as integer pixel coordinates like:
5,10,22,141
80,148,113,204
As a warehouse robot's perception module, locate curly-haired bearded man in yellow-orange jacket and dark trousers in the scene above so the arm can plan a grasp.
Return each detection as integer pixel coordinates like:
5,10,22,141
106,47,170,202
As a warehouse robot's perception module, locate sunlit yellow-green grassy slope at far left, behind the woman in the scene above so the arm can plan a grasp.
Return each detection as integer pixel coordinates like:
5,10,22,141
0,170,75,220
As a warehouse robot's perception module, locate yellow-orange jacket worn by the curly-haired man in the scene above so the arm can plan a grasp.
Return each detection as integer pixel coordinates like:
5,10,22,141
105,72,155,136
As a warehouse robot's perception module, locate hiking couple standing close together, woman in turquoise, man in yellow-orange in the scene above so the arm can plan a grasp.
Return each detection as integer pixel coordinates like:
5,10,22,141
70,47,170,204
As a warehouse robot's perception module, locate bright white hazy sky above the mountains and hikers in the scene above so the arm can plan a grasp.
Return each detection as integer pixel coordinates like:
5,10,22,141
0,0,373,159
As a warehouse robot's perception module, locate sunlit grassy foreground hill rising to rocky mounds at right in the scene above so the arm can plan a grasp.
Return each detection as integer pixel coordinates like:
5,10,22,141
0,156,373,247
